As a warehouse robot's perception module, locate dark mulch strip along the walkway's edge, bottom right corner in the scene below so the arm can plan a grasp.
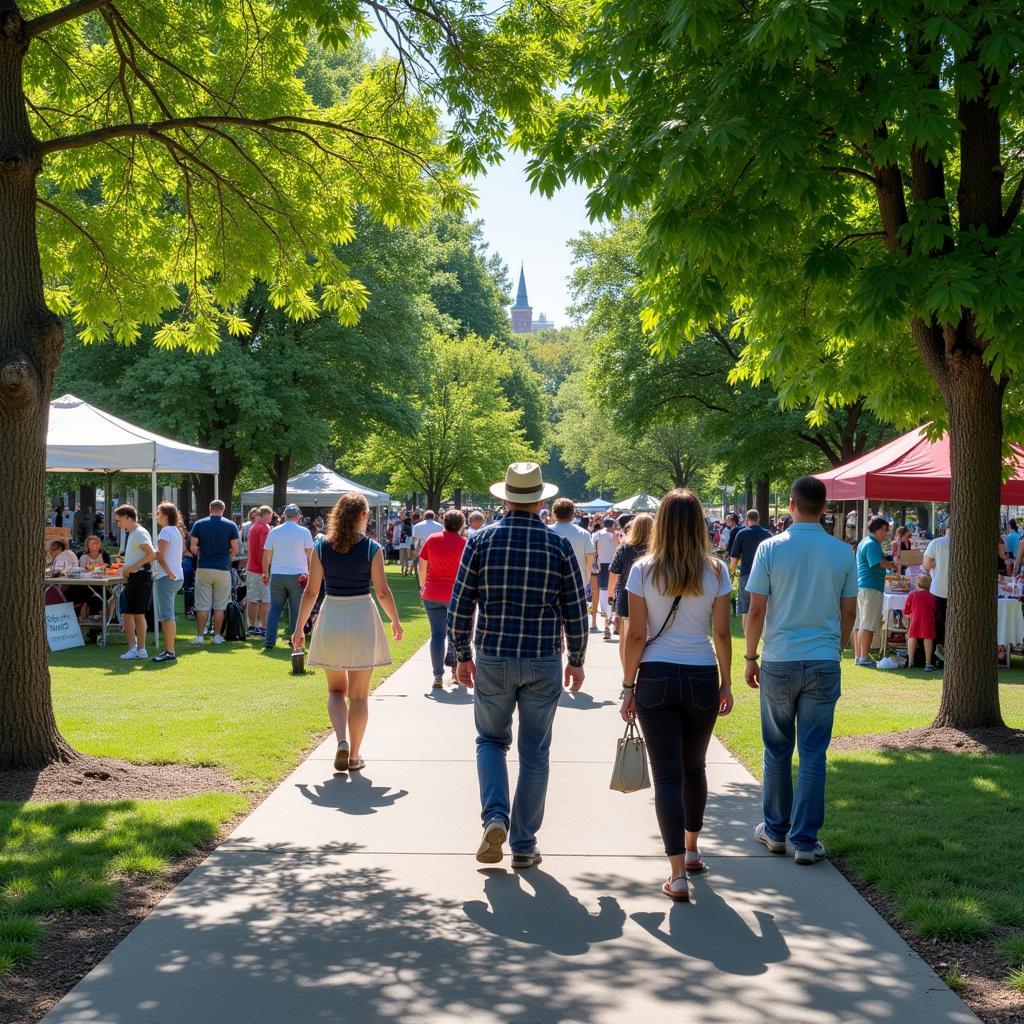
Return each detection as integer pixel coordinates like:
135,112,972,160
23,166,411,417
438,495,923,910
830,856,1024,1024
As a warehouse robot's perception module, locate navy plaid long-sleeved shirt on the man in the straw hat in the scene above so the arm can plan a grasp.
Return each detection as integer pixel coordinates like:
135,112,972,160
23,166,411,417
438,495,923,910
447,511,589,666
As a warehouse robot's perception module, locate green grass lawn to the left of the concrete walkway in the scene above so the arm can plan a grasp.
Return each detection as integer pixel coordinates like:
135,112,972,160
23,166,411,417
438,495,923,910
0,568,430,979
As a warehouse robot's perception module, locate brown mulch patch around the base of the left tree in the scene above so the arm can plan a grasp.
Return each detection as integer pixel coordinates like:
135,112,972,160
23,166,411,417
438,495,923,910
0,757,240,803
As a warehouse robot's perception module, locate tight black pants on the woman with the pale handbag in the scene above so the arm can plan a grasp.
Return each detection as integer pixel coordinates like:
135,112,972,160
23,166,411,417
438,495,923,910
636,662,719,857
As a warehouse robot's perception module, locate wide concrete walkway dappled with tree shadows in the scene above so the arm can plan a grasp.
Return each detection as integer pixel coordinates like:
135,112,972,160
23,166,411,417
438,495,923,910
46,636,977,1024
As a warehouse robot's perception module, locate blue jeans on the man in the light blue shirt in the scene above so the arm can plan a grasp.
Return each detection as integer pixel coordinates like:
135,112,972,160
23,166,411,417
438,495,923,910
761,662,840,850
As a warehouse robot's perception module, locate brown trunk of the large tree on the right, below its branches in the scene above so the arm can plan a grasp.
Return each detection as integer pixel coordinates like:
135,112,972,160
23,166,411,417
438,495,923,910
933,353,1002,729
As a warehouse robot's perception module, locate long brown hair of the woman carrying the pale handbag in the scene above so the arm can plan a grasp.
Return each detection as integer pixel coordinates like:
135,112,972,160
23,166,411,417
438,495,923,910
641,487,722,597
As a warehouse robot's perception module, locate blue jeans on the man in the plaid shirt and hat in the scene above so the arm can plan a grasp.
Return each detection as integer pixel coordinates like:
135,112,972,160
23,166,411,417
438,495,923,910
473,654,562,853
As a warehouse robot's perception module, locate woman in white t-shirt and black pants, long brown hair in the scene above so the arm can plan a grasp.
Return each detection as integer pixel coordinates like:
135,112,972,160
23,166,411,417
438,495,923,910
622,489,732,901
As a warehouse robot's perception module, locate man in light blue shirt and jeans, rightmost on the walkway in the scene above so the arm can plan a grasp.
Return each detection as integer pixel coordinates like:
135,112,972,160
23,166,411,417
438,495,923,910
745,476,857,864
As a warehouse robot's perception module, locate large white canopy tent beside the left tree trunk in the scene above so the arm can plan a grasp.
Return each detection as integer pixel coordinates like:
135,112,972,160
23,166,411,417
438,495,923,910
46,394,220,537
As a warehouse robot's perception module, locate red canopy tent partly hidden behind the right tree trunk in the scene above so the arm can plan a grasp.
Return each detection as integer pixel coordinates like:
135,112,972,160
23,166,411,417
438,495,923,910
815,424,1024,505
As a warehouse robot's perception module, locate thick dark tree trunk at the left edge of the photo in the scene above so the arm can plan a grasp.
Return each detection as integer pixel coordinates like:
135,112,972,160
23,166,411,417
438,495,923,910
0,6,77,769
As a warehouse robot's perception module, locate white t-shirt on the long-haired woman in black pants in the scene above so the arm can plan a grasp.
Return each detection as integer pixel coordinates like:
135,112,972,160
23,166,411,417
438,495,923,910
626,558,732,665
